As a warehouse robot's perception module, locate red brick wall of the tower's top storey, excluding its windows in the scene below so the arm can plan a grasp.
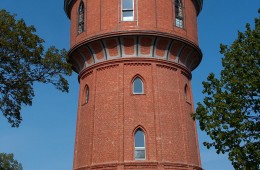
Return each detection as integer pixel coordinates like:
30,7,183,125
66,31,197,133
71,0,198,47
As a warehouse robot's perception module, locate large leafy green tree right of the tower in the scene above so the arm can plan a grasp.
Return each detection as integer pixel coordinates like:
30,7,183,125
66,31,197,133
194,10,260,170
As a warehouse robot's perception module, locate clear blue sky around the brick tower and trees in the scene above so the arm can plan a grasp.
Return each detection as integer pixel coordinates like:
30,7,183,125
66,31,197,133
0,0,260,170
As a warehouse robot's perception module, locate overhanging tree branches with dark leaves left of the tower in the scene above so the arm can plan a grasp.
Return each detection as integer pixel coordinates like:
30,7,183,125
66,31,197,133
0,10,72,127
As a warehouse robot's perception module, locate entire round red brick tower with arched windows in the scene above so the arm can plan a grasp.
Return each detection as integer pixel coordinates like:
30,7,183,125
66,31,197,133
64,0,203,170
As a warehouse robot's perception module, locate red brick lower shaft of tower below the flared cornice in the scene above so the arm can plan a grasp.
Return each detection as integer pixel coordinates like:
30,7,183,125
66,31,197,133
74,57,201,170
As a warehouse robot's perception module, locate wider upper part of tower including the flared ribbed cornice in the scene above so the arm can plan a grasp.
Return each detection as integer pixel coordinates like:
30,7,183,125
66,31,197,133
64,0,203,73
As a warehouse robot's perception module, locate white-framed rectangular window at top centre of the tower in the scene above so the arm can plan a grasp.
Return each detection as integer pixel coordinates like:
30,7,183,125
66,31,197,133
122,0,134,21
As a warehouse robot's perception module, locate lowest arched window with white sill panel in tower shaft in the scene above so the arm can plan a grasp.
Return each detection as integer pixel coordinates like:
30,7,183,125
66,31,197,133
135,128,146,160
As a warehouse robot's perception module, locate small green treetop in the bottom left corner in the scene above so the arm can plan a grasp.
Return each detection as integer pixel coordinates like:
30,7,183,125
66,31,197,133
0,153,23,170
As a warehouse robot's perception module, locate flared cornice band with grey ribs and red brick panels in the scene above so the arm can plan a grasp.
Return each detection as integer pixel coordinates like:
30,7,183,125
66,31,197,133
68,34,202,73
